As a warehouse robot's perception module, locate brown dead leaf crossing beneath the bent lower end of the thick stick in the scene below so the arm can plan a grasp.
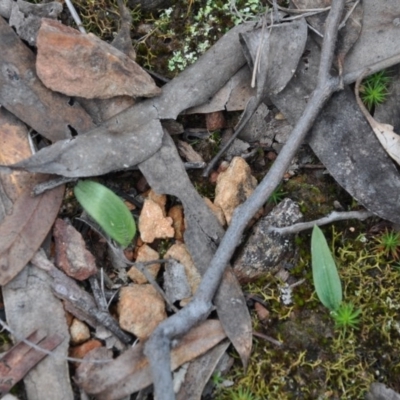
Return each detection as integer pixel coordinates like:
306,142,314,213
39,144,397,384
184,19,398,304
76,320,226,400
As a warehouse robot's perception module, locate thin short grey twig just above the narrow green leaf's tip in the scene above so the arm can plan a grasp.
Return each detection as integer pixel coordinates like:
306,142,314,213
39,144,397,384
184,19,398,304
268,211,374,235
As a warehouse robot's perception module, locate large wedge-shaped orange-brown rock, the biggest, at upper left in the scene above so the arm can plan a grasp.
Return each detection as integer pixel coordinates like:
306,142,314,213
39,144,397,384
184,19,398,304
36,18,161,99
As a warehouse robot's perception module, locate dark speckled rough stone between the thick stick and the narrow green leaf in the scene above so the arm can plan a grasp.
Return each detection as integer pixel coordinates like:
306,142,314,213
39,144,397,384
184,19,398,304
233,198,303,283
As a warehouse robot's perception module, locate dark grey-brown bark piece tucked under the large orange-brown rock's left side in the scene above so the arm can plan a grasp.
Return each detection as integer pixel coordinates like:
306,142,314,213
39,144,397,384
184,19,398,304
0,18,94,142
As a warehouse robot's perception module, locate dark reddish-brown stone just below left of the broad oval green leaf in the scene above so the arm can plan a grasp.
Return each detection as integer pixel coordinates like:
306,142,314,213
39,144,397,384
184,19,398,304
53,219,97,281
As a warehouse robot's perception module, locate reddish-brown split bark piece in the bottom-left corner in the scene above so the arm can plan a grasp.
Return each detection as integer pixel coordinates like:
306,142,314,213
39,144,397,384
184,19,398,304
0,331,64,392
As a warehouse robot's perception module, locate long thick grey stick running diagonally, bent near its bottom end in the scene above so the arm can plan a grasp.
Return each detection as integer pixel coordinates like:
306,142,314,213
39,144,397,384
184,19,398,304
145,0,344,400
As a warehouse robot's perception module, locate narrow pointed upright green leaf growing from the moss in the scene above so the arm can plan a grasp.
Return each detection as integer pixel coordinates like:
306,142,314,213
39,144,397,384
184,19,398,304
311,225,342,311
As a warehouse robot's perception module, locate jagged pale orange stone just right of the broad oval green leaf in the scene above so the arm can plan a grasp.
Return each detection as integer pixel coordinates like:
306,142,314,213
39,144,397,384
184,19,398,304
139,199,175,243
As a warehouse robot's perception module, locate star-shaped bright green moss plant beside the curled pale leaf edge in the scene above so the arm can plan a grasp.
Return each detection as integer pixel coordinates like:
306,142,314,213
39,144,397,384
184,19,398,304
360,71,390,110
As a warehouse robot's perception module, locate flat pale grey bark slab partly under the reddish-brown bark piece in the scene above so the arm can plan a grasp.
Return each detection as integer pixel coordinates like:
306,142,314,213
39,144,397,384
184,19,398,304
2,264,74,400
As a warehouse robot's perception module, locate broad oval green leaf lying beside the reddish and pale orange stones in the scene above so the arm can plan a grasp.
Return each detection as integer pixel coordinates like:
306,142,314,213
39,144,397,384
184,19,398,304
74,180,136,248
